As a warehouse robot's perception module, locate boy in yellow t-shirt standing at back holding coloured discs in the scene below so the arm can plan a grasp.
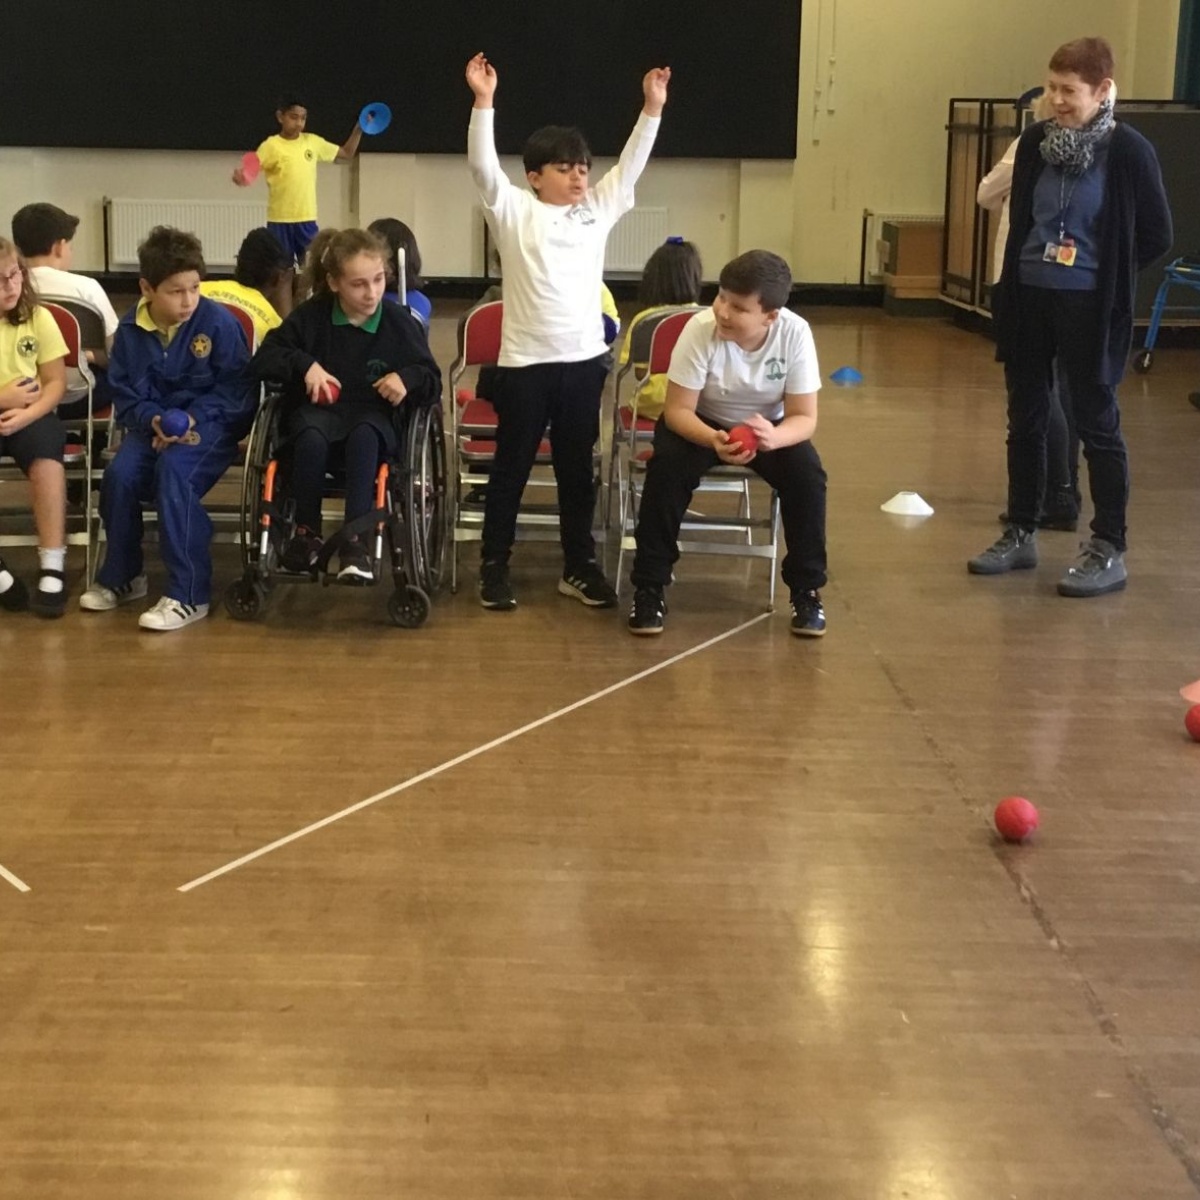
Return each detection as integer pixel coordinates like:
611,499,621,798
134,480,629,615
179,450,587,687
233,95,362,317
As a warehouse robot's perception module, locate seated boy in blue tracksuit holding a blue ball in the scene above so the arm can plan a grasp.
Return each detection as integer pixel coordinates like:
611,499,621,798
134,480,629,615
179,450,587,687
79,226,254,632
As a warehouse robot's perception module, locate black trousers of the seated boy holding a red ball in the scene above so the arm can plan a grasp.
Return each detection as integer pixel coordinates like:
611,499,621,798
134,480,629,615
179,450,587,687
630,418,827,592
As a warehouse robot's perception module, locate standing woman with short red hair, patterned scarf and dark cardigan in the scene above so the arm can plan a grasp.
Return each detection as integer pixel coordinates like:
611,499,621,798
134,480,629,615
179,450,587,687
967,37,1172,596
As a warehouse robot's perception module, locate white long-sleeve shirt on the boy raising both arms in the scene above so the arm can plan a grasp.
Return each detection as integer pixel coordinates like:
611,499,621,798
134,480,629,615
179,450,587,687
467,108,660,367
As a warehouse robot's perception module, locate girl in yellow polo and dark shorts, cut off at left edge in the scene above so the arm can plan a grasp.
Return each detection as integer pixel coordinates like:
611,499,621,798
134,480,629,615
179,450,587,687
0,238,67,617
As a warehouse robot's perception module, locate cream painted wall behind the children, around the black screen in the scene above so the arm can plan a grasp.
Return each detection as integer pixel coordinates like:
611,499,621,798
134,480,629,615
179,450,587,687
0,0,1178,283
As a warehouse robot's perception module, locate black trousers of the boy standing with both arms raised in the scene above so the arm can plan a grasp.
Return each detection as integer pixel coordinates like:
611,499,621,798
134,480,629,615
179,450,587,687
482,355,608,570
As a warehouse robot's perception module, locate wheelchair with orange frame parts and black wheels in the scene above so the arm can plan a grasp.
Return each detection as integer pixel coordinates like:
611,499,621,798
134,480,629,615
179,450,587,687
224,394,450,629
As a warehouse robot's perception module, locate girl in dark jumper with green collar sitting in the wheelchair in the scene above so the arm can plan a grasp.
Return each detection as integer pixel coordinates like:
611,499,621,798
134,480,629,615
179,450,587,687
253,229,442,584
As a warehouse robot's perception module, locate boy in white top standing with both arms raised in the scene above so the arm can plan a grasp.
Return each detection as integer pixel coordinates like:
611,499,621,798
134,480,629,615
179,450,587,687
467,54,671,612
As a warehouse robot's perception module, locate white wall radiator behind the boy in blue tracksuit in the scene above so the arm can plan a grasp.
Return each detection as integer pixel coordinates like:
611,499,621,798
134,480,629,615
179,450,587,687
104,196,266,271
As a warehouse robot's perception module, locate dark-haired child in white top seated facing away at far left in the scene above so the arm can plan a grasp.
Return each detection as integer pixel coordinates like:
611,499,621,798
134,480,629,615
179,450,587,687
12,204,116,418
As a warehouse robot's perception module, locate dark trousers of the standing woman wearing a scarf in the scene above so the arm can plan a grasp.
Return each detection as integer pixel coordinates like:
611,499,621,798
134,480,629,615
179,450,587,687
1004,284,1129,550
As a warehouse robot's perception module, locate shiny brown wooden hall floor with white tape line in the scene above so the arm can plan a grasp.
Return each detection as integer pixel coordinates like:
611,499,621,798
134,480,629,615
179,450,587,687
0,310,1200,1200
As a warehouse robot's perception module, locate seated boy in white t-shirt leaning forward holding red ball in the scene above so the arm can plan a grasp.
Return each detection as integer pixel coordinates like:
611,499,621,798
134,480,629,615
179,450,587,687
629,250,826,637
